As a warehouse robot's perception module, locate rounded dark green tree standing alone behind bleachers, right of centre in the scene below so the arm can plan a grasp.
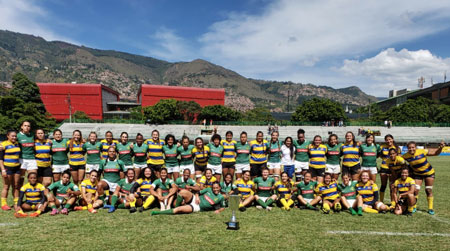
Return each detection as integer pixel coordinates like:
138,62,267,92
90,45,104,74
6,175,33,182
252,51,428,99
291,98,347,122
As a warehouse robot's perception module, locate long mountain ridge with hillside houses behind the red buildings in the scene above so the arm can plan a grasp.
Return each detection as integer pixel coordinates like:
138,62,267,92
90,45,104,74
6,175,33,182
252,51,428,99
0,30,376,112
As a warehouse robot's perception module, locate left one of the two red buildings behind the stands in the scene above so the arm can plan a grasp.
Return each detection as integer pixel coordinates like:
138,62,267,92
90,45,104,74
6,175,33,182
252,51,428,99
37,83,119,121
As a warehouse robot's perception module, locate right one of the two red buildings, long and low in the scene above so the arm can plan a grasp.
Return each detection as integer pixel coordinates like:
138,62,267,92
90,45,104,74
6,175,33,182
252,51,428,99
137,85,225,107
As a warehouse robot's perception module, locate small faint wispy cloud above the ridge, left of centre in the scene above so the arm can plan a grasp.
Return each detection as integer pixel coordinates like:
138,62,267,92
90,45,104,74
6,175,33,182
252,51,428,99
147,27,193,61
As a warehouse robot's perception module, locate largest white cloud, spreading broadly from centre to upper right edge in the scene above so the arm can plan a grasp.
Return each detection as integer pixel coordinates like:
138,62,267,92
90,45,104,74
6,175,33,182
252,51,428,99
199,0,450,82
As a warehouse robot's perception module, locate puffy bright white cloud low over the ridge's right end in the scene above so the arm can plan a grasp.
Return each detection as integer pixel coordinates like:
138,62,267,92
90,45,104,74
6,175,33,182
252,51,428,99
337,48,450,92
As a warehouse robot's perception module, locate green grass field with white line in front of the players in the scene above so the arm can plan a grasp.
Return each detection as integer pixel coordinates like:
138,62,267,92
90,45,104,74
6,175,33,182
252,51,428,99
0,157,450,250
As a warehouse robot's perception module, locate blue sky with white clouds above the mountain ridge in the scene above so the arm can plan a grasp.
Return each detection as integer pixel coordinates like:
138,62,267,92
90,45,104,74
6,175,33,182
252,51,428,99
0,0,450,97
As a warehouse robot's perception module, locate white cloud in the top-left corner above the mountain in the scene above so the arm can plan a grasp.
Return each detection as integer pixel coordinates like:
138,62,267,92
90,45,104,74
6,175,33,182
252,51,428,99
0,0,74,44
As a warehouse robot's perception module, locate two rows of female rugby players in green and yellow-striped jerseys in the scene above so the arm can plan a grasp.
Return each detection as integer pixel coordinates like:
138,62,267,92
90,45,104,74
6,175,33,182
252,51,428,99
0,121,444,218
